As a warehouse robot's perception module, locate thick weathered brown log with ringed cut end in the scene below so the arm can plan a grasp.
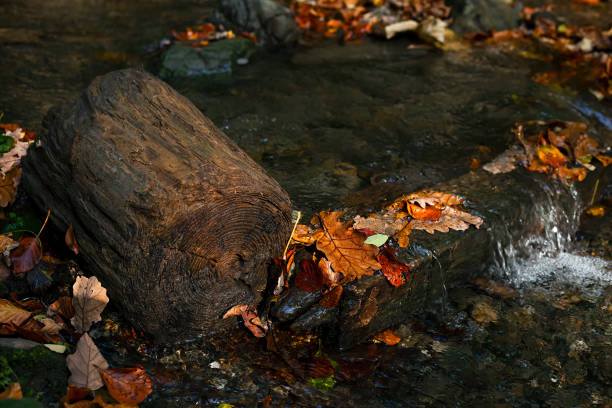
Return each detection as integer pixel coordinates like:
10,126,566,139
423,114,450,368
23,70,291,342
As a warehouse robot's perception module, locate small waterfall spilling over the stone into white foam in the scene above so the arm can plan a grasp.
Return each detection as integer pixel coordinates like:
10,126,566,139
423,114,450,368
490,181,612,287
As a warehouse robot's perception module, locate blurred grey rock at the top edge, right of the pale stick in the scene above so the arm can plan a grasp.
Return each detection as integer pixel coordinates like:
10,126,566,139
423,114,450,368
451,0,521,34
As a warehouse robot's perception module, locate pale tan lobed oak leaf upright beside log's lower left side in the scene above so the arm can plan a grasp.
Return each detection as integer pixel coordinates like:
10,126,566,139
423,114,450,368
70,276,108,333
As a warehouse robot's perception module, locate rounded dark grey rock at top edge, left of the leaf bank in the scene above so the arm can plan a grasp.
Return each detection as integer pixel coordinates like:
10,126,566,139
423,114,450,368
215,0,300,49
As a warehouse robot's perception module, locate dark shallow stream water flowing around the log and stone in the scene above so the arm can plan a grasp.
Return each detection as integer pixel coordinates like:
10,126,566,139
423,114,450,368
0,0,612,408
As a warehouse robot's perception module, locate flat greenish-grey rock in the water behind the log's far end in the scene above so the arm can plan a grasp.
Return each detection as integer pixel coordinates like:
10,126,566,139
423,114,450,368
159,38,259,79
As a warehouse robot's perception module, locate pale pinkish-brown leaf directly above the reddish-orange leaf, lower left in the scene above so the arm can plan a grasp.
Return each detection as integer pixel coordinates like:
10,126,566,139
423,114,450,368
66,333,108,390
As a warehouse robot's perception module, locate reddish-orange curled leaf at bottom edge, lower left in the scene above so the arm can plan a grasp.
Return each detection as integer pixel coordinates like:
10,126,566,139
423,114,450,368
100,368,153,405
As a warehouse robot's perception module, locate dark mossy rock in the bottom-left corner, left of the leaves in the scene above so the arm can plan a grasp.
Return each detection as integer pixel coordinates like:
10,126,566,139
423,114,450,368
0,346,69,408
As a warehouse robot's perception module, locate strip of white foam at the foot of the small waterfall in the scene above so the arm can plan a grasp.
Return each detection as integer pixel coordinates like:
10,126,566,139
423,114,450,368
511,252,612,287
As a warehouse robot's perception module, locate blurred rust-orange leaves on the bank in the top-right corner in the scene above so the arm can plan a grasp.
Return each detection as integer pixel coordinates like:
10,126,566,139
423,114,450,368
467,7,612,99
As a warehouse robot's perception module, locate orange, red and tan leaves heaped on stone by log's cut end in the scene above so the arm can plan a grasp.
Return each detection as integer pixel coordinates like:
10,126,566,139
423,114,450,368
224,191,483,337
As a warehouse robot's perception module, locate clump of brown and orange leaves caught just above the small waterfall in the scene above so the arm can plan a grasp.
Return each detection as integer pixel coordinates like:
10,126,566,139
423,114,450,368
483,120,612,182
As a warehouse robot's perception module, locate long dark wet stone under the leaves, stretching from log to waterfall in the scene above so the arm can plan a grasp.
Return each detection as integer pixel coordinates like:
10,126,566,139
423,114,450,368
272,166,610,348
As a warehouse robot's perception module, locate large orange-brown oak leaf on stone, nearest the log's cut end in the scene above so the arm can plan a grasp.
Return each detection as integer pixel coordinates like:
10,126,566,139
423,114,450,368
317,211,380,283
